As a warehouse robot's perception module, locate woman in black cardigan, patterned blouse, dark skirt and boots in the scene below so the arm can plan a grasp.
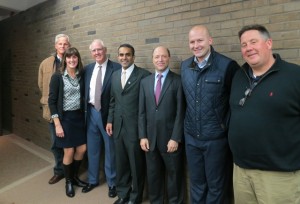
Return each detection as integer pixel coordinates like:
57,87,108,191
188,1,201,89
48,47,86,197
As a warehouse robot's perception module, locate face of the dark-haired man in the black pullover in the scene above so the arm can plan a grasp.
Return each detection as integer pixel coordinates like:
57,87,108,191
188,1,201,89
240,30,273,69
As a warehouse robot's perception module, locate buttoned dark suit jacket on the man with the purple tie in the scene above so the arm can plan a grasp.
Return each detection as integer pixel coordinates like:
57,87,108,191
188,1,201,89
138,70,185,152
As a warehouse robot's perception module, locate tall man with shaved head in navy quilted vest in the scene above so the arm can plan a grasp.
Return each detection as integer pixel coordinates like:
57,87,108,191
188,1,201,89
181,25,239,204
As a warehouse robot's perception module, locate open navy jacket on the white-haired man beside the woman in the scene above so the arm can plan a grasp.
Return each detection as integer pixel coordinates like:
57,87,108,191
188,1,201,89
84,60,121,126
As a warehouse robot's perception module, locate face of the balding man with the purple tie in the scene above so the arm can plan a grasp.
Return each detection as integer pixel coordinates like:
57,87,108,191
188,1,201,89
152,47,170,73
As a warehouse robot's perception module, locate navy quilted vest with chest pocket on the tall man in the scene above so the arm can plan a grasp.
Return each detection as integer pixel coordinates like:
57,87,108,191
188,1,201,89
181,47,239,140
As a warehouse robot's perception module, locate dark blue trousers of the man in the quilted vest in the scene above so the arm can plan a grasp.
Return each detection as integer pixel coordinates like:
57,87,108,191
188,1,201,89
185,135,232,204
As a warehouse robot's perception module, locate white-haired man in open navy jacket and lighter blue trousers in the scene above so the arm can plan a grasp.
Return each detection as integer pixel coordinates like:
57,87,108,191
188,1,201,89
82,39,121,197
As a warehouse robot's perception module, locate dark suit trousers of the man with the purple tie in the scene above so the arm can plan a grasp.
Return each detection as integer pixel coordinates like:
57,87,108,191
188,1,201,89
146,147,184,204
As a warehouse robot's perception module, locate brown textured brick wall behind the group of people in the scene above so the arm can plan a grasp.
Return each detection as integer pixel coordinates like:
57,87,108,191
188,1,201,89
0,0,300,148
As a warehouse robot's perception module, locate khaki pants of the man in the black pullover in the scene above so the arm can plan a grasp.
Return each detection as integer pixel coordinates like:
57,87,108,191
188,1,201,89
233,164,300,204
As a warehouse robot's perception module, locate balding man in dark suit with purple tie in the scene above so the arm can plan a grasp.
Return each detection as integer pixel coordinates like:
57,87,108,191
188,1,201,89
138,46,184,204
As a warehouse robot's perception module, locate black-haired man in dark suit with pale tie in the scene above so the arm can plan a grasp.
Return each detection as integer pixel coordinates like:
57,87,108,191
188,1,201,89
106,44,150,204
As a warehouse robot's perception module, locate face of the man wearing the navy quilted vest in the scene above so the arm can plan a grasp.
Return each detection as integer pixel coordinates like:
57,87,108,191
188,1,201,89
189,27,212,62
